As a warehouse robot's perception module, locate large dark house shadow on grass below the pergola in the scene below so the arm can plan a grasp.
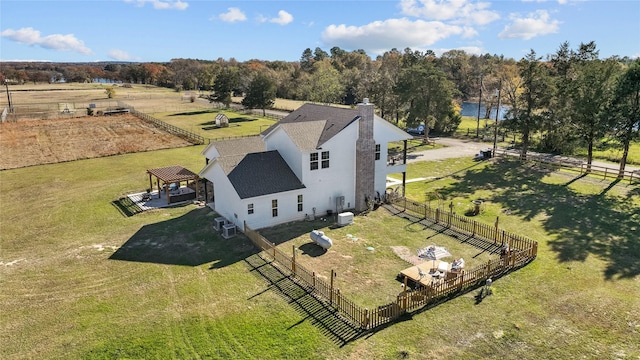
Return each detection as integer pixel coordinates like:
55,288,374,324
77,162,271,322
109,208,257,269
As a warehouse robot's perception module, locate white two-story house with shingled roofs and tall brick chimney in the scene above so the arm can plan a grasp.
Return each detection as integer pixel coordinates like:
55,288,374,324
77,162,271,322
200,99,412,229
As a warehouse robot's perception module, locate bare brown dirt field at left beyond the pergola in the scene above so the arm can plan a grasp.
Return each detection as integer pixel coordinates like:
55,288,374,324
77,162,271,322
0,114,191,170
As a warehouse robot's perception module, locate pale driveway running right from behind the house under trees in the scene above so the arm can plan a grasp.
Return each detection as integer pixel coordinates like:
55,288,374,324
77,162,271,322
407,138,640,171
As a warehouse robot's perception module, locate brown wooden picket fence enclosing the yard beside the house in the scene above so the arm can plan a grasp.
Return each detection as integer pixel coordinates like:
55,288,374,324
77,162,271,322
244,198,538,329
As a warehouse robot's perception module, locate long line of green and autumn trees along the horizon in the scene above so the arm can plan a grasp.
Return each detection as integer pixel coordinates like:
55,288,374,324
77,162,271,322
0,42,640,176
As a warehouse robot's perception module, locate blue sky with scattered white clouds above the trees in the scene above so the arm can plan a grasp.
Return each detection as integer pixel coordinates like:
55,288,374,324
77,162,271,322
0,0,640,62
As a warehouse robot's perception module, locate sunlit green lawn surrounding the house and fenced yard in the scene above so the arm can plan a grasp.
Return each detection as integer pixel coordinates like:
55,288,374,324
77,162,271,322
0,146,640,359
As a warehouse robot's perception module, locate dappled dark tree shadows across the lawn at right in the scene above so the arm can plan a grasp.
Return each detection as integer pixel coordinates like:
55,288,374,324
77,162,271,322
440,159,640,279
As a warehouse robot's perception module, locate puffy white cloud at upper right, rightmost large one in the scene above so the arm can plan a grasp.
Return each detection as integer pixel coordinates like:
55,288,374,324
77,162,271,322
498,10,560,40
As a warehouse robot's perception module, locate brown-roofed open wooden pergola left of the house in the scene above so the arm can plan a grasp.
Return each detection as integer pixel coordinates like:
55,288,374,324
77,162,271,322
147,165,199,204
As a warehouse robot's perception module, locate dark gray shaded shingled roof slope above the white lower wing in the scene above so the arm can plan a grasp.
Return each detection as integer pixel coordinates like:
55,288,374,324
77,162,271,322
228,150,305,199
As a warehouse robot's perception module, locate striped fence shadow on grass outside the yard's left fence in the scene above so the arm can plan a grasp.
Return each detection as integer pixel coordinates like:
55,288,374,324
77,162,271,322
245,254,364,346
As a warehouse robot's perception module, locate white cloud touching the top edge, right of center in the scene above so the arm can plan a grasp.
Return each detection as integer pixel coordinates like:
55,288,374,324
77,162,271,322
400,0,500,25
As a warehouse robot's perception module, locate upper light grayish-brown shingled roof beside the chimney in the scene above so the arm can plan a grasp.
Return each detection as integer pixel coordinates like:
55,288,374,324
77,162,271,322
263,104,359,149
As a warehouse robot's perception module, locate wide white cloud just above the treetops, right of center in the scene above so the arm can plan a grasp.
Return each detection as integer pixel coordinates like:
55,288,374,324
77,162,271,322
322,18,466,54
